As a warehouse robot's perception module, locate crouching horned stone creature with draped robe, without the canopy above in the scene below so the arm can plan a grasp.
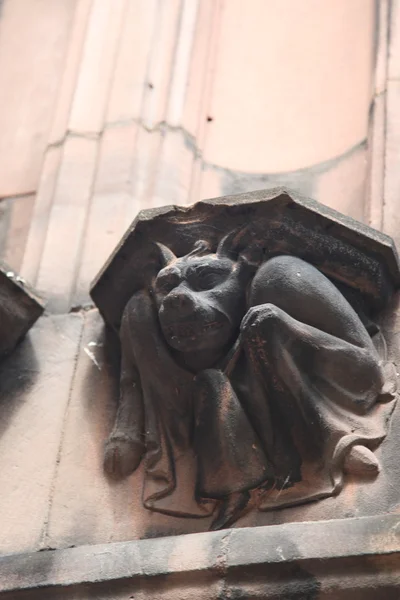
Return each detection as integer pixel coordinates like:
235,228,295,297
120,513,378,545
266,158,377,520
101,232,393,528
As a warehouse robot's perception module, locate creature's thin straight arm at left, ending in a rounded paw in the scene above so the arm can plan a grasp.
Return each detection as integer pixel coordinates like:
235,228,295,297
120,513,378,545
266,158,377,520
104,304,145,478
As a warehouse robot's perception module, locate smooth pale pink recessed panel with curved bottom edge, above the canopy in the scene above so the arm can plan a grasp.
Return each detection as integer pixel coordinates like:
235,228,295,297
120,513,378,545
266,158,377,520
204,0,375,173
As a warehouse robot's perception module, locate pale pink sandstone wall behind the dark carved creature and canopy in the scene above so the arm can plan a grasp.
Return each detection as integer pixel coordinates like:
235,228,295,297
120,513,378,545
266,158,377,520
0,0,400,552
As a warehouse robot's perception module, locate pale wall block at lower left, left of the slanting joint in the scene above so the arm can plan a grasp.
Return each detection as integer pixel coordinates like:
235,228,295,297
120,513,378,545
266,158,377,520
0,314,82,554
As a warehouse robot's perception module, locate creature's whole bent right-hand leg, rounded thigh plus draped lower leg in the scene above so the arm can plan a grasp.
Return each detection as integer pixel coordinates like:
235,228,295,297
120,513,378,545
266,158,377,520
241,256,383,492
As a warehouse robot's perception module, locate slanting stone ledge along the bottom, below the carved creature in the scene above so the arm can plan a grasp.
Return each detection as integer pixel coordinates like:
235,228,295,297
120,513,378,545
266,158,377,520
0,515,400,600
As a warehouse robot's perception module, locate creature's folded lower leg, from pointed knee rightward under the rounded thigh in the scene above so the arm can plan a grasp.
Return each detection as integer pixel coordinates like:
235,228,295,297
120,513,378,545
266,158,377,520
242,304,383,412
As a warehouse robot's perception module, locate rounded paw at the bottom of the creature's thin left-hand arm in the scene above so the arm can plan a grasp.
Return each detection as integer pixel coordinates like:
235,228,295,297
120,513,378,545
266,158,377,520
104,433,144,479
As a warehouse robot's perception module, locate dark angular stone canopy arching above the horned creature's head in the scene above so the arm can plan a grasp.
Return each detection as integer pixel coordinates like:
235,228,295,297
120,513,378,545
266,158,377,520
91,188,400,330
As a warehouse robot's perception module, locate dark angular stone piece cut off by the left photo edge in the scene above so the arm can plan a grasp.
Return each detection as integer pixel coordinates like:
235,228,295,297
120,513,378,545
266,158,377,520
0,265,44,358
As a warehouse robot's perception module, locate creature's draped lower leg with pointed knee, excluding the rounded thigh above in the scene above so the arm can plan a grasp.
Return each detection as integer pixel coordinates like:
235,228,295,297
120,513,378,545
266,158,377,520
242,304,382,485
